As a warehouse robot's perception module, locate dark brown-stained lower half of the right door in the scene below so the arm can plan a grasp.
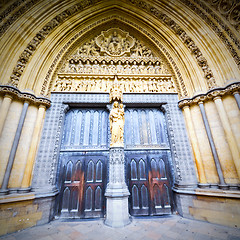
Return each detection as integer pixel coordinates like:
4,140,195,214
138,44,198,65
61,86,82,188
126,151,172,216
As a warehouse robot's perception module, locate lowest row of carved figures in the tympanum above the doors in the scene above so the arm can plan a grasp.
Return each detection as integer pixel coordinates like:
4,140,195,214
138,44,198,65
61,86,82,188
53,74,176,93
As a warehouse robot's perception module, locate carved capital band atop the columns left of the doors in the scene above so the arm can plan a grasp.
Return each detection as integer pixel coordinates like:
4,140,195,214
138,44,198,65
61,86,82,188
0,85,51,108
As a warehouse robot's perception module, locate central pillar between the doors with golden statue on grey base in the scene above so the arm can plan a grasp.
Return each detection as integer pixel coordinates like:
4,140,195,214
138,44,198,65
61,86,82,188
105,78,130,227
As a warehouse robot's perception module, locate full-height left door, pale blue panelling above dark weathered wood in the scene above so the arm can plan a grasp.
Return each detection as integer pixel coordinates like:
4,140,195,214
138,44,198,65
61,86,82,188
57,108,109,218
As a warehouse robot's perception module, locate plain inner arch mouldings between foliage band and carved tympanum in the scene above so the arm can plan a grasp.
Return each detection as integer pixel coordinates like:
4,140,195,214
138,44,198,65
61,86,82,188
11,4,206,96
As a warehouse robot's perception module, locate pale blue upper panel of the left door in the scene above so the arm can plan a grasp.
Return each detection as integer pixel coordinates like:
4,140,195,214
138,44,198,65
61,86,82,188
61,108,109,150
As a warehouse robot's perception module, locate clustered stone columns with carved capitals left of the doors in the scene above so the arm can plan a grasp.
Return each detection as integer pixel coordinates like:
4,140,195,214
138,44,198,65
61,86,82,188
0,85,51,195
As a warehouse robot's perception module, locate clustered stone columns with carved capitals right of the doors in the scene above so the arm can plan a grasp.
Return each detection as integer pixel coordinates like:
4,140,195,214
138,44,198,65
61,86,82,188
179,82,240,189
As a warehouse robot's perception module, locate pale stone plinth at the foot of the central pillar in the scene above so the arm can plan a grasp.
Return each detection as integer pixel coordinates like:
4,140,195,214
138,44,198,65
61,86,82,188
105,188,131,227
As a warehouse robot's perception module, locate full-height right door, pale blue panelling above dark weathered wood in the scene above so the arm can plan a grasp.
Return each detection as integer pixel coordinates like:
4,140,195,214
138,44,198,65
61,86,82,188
124,108,172,216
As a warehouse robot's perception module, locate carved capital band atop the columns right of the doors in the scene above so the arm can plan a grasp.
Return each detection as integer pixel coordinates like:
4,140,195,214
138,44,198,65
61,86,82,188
178,82,240,108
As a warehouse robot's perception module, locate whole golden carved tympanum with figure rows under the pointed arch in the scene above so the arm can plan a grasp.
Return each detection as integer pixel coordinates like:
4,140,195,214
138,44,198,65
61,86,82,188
53,28,176,93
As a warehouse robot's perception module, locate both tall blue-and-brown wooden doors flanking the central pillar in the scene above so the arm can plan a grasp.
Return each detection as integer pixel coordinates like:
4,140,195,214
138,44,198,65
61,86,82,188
57,108,172,218
